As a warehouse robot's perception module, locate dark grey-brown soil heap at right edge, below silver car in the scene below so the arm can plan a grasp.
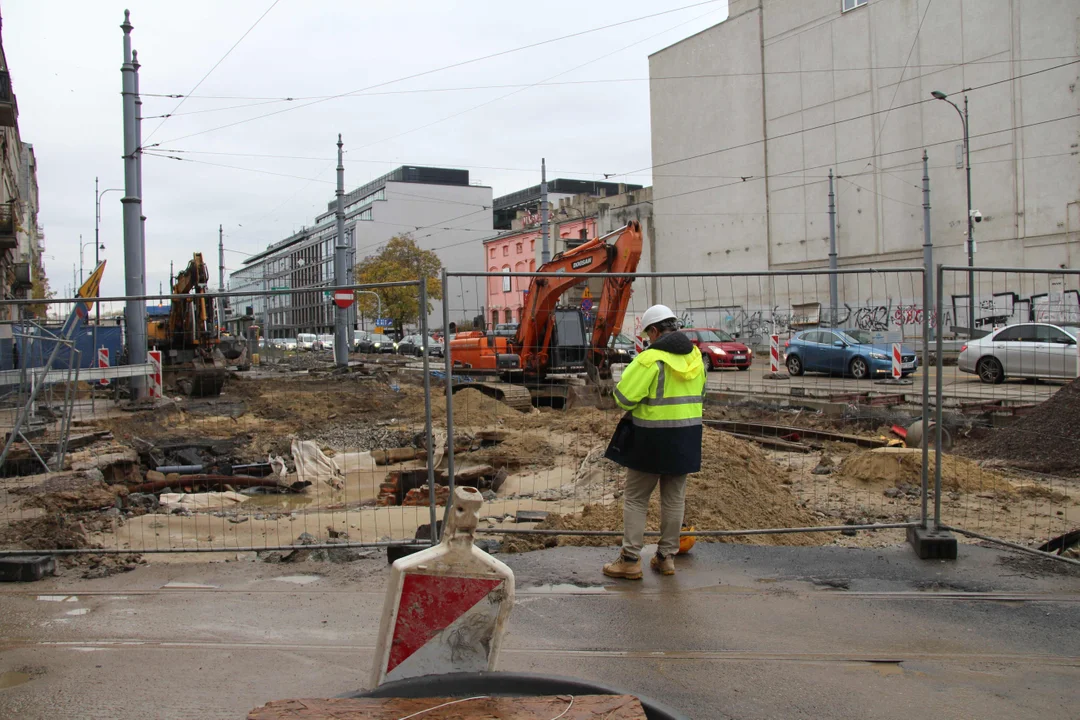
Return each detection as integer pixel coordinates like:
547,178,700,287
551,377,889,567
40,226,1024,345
962,380,1080,475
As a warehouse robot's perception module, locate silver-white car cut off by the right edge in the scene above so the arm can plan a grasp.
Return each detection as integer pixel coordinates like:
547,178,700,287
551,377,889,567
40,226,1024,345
957,323,1080,384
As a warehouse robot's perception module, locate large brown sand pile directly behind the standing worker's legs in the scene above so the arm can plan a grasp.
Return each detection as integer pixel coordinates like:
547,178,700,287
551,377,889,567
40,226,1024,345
503,429,827,553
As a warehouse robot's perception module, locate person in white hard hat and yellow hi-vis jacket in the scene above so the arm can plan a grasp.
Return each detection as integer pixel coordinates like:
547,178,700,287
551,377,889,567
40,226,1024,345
604,305,705,580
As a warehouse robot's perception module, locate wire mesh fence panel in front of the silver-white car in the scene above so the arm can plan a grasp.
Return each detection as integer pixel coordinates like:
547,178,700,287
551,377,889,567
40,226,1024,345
937,267,1080,556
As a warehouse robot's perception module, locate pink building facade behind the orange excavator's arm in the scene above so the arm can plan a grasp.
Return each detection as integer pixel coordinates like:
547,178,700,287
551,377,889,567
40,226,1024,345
484,213,596,326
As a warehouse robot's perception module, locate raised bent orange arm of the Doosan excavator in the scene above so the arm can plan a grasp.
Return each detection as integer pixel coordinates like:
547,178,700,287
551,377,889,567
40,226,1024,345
511,222,642,377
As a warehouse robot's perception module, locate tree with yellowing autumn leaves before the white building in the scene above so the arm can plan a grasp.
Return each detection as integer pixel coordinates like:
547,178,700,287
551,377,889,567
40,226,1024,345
354,233,443,332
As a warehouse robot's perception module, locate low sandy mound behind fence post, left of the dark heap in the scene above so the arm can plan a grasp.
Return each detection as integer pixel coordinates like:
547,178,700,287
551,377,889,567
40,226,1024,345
839,448,1013,493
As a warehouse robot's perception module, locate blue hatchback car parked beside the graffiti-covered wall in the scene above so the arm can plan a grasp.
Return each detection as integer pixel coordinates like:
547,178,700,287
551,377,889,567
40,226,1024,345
785,329,919,380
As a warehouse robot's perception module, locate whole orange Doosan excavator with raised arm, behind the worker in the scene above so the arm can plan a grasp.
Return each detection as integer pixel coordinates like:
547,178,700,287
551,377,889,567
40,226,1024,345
450,222,642,405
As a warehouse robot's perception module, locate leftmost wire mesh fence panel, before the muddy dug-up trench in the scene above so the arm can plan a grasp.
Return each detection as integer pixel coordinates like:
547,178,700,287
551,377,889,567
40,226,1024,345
0,281,445,559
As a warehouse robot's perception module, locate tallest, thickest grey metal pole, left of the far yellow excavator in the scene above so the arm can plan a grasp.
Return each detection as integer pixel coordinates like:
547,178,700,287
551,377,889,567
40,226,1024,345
120,10,146,399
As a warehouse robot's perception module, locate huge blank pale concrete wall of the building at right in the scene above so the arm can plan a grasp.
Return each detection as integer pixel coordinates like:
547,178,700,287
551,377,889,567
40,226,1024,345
650,0,1080,321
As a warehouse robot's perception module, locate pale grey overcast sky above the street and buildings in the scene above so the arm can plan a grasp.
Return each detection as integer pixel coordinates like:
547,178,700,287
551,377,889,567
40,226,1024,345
2,0,727,295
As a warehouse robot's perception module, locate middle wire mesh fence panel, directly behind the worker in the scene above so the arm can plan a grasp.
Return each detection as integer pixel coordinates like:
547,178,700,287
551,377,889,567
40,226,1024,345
434,264,929,548
